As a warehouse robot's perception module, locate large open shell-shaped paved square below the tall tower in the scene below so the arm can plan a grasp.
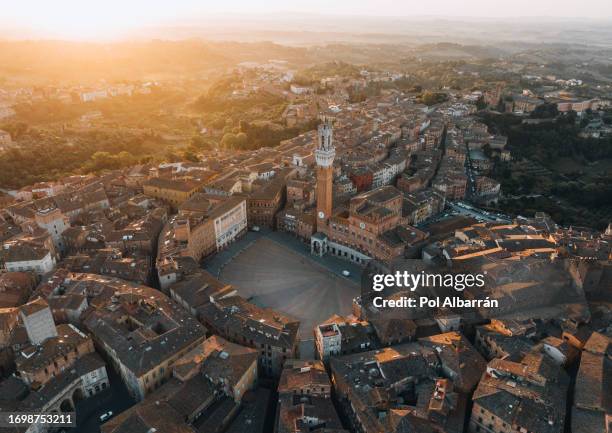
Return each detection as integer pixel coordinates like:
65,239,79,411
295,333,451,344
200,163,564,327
220,238,359,340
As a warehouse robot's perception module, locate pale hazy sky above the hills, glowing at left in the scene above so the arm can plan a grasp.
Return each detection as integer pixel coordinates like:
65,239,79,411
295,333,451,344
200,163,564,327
0,0,612,38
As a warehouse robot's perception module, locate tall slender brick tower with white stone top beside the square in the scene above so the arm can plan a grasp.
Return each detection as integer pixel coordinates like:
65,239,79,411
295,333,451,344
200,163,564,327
315,119,336,231
